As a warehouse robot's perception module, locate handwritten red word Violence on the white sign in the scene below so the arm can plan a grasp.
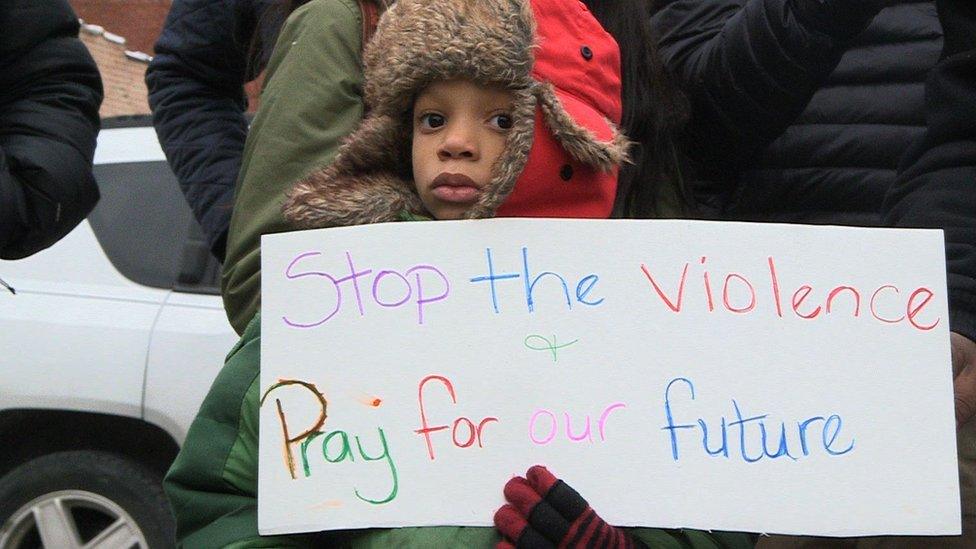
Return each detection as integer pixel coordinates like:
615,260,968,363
641,256,942,331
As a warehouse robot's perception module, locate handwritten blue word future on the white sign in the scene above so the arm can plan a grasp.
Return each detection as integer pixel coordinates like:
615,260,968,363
661,377,854,463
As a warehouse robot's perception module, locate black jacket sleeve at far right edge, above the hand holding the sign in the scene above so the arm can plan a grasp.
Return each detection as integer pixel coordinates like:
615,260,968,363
883,0,976,341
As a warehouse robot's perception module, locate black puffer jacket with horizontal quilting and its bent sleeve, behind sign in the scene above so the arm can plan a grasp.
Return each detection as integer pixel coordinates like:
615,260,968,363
655,0,942,225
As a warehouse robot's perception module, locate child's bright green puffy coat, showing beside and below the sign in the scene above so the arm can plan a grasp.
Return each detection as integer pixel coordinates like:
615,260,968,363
164,315,752,549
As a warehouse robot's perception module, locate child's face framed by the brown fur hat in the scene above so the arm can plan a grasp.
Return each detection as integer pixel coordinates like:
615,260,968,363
413,80,514,219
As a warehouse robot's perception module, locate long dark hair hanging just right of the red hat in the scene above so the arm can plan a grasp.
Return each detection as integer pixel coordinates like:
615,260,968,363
583,0,693,217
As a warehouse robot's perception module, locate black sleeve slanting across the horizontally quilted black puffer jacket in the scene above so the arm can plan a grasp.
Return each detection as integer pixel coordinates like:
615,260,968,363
652,0,878,171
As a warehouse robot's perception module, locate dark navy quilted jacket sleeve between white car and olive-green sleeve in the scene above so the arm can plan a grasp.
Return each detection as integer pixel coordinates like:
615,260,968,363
146,0,283,261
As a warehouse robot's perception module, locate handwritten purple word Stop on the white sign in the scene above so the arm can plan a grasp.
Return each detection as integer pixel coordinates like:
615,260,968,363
281,252,451,328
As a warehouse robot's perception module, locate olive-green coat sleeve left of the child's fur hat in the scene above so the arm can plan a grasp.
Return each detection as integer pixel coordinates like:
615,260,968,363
221,0,363,333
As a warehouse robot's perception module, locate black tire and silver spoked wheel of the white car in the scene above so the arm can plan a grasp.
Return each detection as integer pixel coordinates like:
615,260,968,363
0,451,175,549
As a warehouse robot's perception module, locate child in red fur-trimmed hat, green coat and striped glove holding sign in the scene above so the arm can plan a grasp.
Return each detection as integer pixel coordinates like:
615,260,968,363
166,0,752,547
